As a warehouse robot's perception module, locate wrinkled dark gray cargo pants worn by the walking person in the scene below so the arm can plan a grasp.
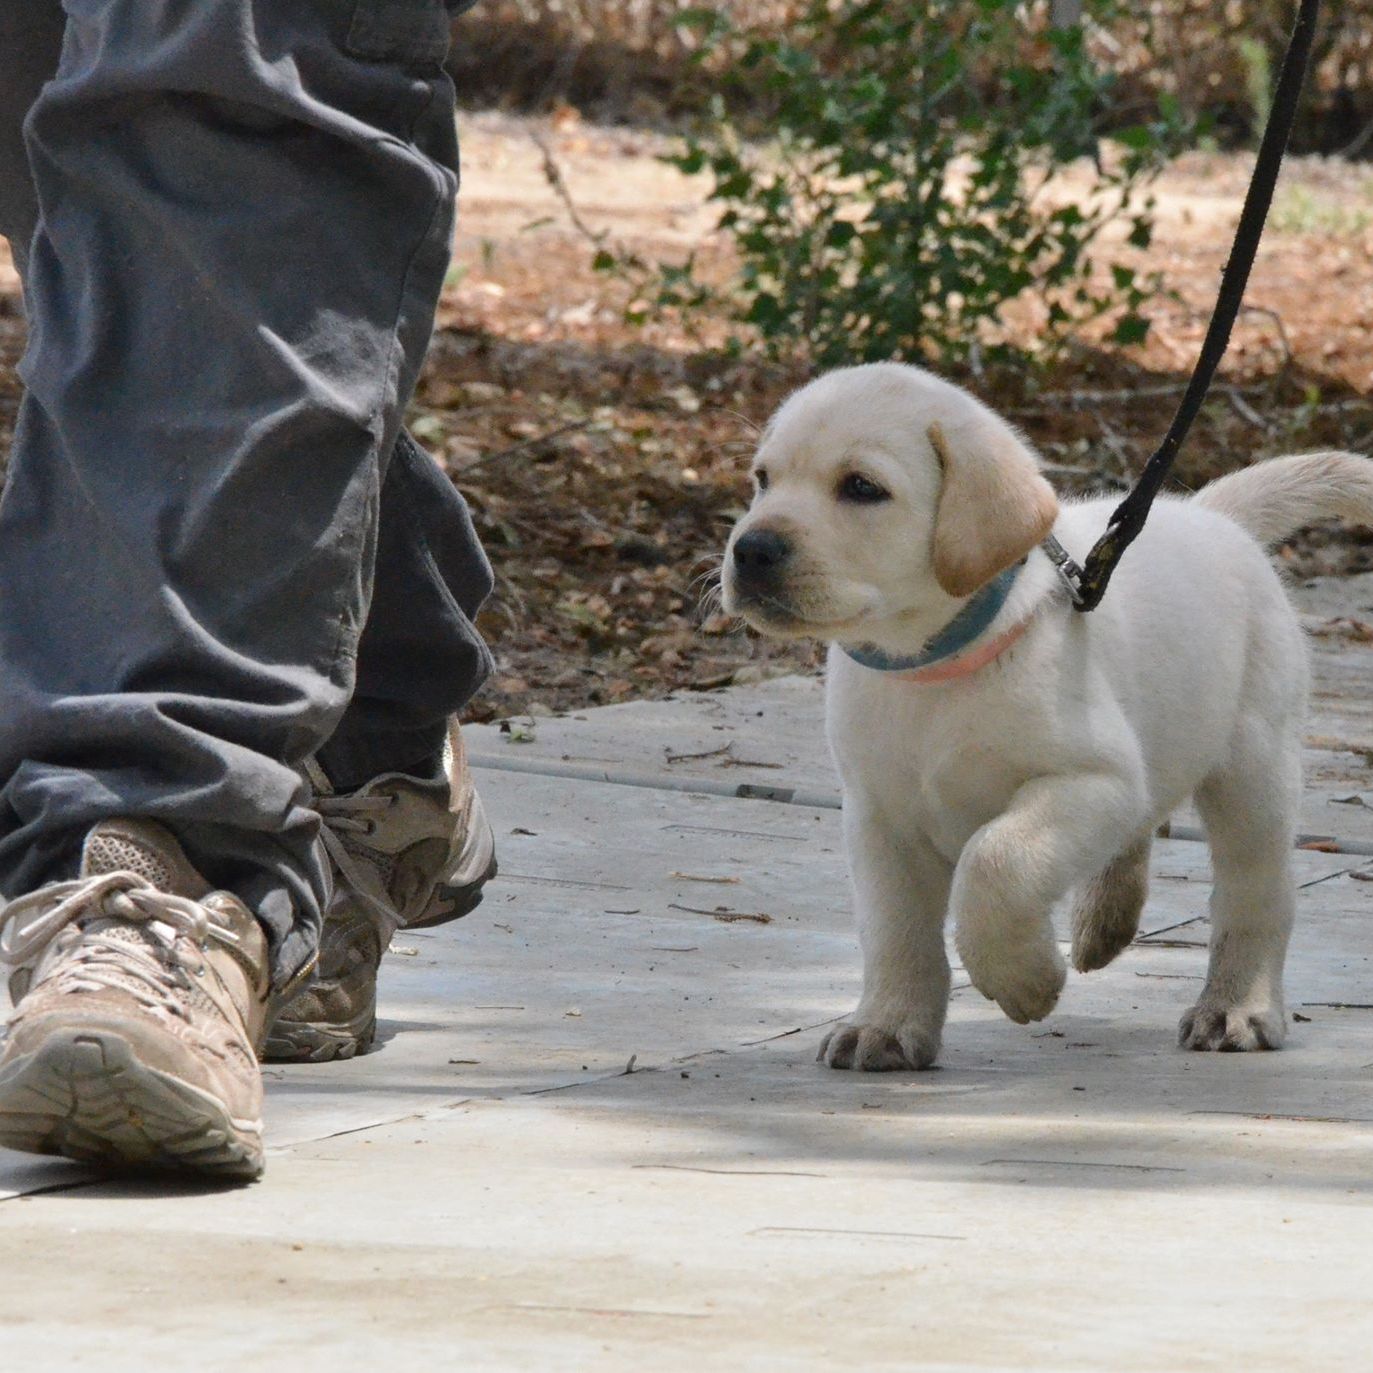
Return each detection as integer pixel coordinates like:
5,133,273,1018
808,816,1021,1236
0,0,490,982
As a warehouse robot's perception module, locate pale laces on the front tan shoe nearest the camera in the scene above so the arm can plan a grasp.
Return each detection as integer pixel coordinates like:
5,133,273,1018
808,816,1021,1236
0,872,222,1019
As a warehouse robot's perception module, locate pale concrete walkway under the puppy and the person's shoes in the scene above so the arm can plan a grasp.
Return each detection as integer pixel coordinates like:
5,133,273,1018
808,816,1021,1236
0,577,1373,1373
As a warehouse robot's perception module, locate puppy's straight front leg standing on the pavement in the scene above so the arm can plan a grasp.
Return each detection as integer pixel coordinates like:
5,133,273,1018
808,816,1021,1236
818,792,953,1072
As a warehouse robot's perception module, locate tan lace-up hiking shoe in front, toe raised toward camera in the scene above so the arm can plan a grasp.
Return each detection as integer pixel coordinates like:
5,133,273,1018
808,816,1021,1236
0,820,269,1178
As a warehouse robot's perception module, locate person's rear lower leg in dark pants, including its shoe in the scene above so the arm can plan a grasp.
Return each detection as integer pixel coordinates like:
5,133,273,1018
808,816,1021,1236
264,432,496,1061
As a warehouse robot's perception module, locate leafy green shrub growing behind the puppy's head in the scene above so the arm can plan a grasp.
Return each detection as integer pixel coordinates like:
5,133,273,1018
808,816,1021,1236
628,0,1181,365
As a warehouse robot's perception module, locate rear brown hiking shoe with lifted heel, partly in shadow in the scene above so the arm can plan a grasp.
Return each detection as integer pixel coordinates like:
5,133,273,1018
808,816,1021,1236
264,722,496,1063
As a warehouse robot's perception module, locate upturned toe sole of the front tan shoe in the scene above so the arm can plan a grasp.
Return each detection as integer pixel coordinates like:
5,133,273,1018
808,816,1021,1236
0,1028,264,1181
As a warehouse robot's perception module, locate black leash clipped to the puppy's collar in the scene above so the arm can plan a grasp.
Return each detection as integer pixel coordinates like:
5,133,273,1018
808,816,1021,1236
1043,0,1321,611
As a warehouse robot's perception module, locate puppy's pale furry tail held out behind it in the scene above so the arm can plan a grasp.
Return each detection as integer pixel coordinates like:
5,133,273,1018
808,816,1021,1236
1192,453,1373,545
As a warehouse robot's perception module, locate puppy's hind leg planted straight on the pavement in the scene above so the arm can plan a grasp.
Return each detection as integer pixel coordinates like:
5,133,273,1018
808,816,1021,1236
1178,730,1302,1052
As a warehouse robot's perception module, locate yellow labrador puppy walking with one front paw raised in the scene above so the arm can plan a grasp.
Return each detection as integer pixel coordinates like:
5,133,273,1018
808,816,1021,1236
724,362,1373,1070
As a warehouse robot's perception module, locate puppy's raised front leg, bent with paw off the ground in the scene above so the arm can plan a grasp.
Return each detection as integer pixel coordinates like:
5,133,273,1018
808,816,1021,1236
950,773,1148,1024
